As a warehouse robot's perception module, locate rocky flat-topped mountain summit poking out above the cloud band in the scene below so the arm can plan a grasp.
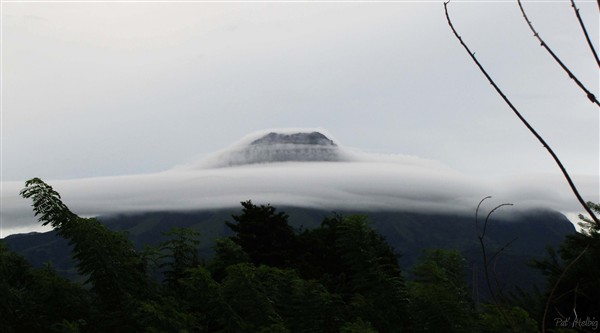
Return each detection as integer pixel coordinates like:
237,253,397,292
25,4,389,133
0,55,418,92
204,131,348,167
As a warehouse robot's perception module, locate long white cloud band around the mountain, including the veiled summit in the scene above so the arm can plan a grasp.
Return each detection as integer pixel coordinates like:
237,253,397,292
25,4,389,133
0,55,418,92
2,129,595,236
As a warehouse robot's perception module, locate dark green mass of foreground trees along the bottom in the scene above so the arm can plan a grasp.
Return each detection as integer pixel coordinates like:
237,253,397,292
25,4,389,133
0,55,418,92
0,179,600,333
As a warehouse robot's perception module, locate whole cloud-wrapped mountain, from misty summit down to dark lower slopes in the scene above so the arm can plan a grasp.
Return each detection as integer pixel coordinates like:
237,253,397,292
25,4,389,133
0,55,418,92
3,130,575,298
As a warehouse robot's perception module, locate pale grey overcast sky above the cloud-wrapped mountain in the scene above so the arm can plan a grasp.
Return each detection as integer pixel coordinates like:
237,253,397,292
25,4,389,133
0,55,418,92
0,1,600,234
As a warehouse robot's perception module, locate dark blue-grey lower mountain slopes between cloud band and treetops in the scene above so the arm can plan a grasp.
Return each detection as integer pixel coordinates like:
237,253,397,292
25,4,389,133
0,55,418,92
5,207,575,297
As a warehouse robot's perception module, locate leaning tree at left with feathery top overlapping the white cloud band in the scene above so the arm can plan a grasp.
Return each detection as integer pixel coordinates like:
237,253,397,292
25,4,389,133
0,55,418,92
21,178,150,332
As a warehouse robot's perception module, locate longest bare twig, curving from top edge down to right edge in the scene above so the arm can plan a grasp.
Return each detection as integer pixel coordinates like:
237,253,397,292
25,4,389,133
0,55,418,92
444,2,600,228
